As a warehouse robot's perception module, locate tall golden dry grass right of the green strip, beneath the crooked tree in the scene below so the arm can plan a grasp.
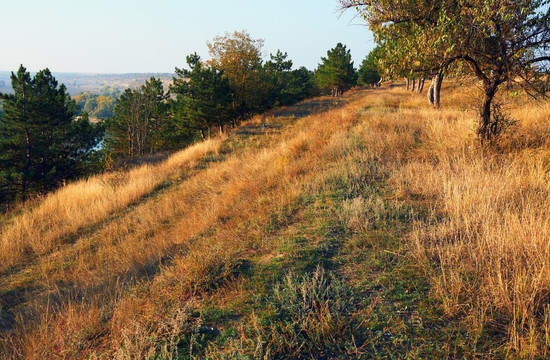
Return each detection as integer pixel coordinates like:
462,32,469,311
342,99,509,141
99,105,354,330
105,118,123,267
376,85,550,358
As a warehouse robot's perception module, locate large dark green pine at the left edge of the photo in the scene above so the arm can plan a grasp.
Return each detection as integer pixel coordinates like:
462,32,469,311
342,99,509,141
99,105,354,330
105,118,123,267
0,66,103,202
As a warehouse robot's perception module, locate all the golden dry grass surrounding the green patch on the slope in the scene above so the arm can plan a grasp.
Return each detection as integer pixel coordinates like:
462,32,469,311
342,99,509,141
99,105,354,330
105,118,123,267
0,85,550,359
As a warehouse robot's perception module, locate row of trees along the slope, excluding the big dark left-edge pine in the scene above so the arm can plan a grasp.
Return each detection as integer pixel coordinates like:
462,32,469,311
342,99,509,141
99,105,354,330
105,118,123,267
104,31,379,160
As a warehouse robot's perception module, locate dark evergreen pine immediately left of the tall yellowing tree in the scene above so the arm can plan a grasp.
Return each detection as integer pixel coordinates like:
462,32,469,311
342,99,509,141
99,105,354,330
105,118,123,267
171,54,234,139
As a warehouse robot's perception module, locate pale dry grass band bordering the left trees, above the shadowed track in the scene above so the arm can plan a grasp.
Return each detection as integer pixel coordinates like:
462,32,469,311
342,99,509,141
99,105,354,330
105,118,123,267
0,140,221,270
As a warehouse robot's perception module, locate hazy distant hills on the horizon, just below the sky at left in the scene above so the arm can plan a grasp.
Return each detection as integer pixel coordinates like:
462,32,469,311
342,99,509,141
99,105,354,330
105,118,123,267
0,71,174,96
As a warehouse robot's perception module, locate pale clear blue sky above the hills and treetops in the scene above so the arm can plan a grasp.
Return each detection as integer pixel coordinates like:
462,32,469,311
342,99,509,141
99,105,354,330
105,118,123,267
0,0,374,73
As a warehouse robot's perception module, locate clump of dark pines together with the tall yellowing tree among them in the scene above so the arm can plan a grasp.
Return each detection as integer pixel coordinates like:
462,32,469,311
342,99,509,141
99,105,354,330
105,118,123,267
170,40,317,139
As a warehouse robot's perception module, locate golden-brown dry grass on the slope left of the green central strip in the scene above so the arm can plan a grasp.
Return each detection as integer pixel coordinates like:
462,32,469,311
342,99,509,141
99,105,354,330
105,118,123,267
0,92,370,359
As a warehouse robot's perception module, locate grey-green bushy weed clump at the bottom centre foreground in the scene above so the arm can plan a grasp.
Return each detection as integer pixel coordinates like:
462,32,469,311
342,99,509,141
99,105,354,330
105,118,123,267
255,266,374,359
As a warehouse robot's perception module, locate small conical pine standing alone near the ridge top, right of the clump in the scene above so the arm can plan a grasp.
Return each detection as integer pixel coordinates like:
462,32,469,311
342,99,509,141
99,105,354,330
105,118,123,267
315,43,357,96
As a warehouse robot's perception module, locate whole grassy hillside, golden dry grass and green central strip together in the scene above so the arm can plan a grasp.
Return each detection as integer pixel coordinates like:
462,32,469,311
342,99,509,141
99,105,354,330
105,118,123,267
0,85,550,359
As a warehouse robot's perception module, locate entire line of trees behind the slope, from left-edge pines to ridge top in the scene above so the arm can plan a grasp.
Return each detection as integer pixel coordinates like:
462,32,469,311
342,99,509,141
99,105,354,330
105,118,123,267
0,31,380,204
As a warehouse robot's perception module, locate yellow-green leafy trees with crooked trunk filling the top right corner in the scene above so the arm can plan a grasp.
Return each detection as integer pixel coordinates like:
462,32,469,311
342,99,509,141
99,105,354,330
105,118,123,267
339,0,550,141
